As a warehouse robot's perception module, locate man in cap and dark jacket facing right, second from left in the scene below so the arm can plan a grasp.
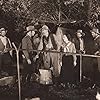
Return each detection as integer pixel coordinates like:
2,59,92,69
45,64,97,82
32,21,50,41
22,26,36,81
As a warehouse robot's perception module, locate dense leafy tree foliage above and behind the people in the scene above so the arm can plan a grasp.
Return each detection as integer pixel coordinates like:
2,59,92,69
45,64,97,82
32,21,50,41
0,0,100,41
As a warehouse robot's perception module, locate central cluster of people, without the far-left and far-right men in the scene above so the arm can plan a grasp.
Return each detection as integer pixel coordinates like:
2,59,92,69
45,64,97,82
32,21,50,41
22,25,85,84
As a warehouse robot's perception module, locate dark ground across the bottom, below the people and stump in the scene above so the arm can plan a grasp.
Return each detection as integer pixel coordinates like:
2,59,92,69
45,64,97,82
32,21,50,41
0,80,99,100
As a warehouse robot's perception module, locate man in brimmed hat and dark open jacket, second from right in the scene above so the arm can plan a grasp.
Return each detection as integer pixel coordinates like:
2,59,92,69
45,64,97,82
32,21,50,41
72,29,85,82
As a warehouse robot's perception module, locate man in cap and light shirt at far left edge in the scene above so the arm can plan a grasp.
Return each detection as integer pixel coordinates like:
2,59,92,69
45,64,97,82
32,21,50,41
0,28,12,75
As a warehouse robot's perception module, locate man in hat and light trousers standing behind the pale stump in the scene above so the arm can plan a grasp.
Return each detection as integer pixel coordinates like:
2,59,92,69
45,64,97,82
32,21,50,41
35,25,60,83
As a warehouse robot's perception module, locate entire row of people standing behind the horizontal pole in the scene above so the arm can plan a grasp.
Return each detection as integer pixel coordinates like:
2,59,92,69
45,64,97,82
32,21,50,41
0,25,100,84
